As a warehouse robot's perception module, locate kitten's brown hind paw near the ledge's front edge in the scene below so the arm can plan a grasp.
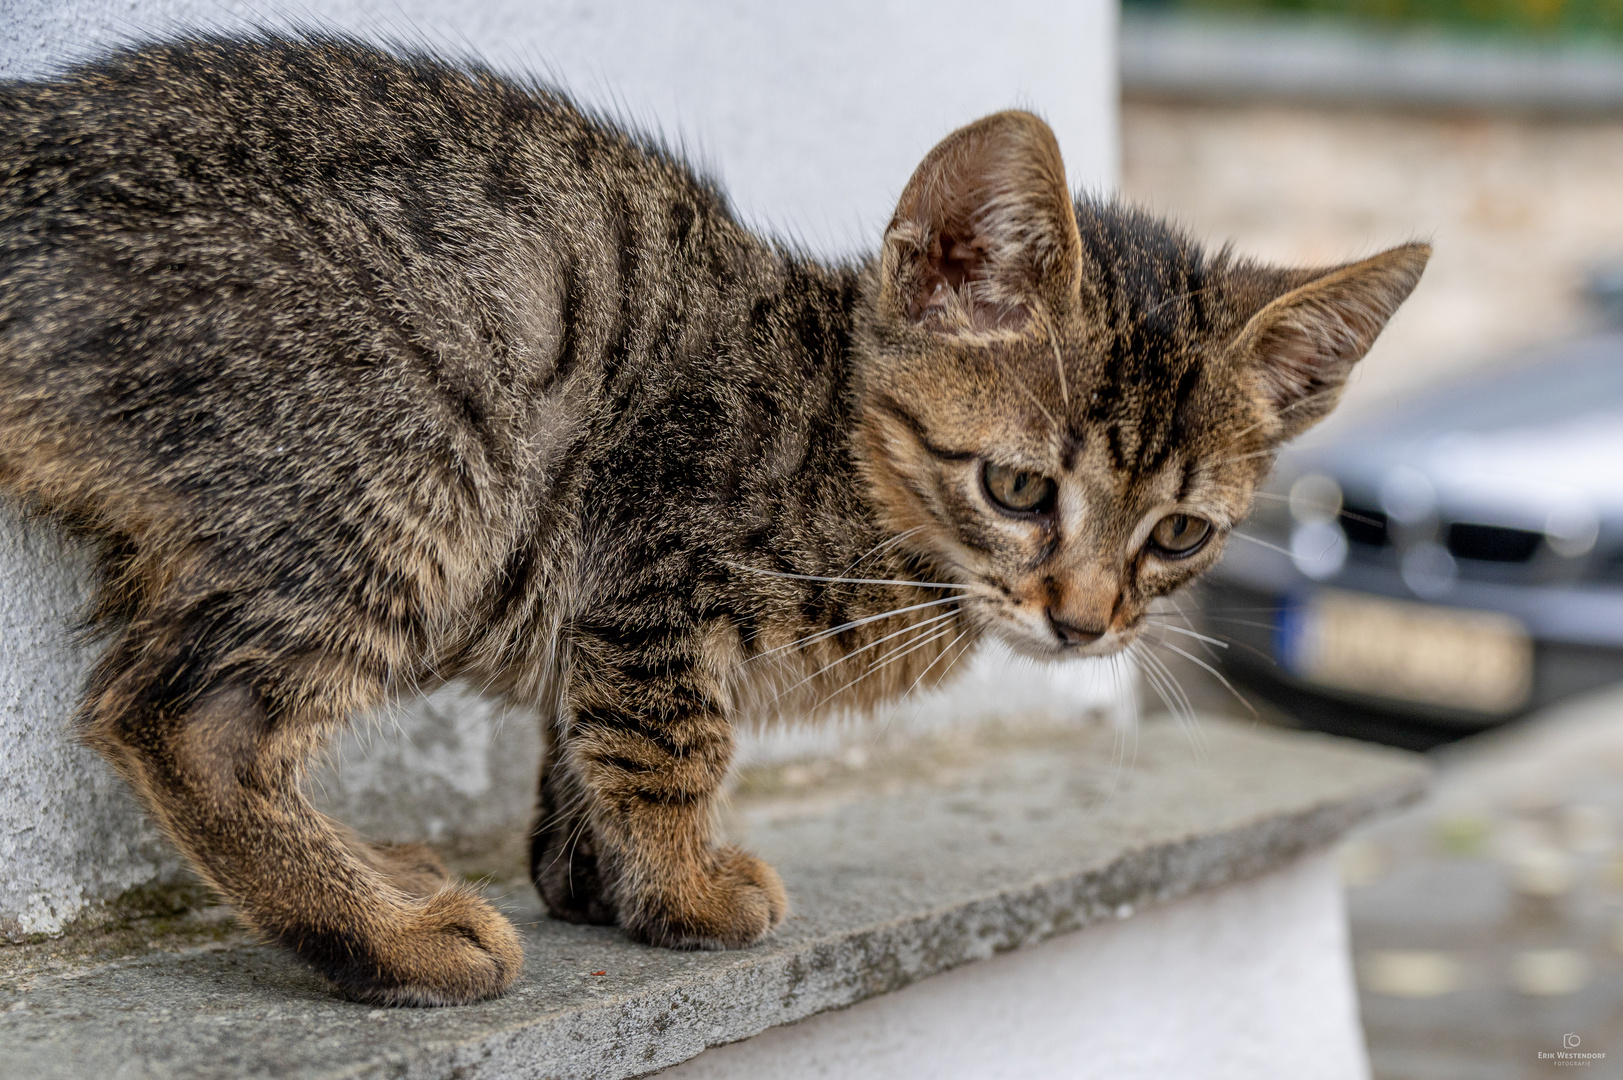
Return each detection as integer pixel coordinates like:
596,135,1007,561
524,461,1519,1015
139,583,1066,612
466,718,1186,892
306,887,524,1005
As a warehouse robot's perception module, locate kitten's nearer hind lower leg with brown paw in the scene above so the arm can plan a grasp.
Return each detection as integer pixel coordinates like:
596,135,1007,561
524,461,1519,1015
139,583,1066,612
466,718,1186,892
86,643,523,1005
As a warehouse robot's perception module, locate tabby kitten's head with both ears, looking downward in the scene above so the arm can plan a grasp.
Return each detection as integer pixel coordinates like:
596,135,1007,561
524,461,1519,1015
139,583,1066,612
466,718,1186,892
859,112,1430,656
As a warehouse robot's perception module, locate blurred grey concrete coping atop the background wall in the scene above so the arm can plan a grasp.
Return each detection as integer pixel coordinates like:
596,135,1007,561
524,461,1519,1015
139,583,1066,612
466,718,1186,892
1121,13,1623,114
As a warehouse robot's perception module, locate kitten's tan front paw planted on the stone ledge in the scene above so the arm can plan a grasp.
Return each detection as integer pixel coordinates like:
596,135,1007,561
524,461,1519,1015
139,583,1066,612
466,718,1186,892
625,848,789,948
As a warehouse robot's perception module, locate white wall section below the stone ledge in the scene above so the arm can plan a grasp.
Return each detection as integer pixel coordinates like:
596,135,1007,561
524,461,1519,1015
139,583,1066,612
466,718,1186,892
659,854,1370,1080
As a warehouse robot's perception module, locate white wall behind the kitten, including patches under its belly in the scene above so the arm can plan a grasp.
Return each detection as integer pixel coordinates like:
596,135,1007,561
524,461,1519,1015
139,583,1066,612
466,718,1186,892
0,0,1120,937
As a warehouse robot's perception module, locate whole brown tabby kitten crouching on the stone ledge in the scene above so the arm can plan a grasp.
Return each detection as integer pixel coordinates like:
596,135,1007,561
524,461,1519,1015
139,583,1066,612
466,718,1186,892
0,32,1430,1005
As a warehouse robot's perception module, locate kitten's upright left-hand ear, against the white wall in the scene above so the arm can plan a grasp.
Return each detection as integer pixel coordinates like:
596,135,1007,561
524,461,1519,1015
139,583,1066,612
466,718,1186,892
880,110,1083,333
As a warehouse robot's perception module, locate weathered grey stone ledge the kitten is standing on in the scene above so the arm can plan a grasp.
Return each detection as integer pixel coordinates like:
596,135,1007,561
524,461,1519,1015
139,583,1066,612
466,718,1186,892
0,721,1425,1080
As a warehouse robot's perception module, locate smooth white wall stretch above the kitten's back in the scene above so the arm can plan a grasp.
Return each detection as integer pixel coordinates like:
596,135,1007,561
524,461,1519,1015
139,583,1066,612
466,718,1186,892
0,0,1117,252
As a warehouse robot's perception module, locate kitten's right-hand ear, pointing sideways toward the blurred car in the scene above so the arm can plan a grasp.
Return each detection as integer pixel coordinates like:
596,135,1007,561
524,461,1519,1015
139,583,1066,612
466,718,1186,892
1233,244,1431,440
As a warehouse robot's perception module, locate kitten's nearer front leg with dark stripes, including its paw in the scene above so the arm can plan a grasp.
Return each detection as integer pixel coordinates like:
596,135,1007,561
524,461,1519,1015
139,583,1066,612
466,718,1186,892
537,654,789,948
